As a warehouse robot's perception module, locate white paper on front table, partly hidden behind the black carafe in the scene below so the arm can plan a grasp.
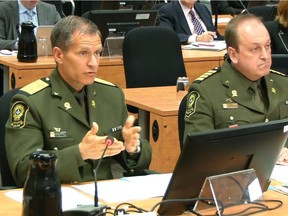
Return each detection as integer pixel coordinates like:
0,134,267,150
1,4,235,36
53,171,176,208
5,186,94,210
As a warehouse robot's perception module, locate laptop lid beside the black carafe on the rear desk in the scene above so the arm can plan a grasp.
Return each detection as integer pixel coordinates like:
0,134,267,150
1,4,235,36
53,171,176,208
36,25,54,56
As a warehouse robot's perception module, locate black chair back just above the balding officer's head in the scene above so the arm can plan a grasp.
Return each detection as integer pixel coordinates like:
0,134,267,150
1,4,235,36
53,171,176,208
244,6,277,22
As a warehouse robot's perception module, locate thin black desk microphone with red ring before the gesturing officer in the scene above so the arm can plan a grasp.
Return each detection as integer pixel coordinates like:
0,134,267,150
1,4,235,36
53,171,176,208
63,125,122,216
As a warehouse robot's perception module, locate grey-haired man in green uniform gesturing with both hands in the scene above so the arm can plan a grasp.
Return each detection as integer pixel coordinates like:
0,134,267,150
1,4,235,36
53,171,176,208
6,16,151,187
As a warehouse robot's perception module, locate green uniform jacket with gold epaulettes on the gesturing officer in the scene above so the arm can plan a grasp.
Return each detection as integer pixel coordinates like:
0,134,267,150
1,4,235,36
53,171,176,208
6,69,152,186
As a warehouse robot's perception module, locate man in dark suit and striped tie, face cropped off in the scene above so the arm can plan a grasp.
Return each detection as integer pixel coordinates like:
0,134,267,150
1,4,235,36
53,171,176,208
158,0,223,44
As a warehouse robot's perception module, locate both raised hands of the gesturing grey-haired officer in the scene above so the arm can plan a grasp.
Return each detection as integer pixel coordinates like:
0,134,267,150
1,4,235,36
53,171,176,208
79,115,141,160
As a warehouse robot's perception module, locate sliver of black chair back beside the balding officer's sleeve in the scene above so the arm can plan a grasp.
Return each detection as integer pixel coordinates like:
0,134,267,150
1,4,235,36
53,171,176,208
178,94,187,150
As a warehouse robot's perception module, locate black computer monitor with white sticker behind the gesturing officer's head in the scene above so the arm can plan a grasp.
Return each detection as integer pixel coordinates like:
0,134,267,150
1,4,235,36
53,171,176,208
82,10,158,44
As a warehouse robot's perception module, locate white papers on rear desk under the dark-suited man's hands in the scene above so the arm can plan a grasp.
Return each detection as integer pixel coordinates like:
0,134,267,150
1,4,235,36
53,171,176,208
183,40,226,51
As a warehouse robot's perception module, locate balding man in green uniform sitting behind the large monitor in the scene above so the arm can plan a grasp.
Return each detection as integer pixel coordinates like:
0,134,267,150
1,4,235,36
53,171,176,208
184,14,288,164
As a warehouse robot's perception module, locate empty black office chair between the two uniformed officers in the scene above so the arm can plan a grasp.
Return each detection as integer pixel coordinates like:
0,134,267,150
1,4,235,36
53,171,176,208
123,26,186,113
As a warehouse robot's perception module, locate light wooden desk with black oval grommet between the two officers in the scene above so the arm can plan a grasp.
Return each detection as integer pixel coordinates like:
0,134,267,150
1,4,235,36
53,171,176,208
123,86,180,173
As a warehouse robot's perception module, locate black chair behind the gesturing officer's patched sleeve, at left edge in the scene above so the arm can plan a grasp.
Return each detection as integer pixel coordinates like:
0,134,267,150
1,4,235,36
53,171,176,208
0,89,18,190
